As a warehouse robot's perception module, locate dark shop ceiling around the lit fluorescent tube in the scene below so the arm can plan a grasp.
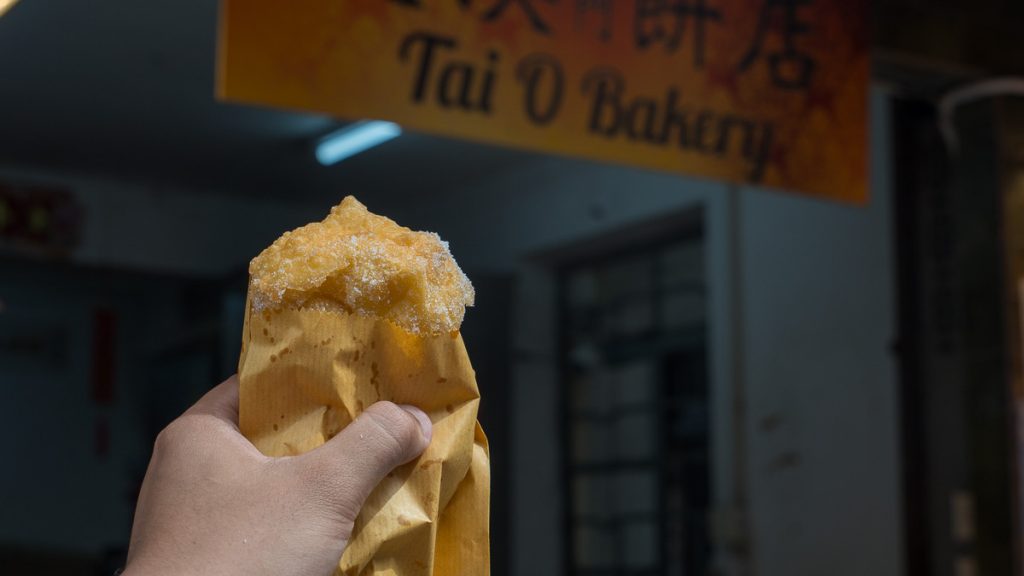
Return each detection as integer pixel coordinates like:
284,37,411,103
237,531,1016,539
0,0,531,199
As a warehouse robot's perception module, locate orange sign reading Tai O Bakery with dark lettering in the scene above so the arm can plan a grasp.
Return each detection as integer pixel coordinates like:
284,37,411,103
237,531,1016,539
218,0,869,202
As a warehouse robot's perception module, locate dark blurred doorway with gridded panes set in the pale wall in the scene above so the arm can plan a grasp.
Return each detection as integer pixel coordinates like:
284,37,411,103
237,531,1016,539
558,211,711,576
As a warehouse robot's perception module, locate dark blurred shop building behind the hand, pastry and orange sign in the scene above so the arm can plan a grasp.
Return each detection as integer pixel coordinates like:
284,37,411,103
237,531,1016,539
0,0,1024,576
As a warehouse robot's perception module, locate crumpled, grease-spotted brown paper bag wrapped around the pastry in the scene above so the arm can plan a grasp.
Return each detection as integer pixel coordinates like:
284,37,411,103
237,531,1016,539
239,295,490,576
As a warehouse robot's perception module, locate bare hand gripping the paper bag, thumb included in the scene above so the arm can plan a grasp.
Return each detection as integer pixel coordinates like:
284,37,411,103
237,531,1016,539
124,376,431,576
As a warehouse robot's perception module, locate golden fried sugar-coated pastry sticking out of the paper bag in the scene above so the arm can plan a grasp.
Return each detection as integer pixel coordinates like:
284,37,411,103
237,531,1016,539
249,196,474,334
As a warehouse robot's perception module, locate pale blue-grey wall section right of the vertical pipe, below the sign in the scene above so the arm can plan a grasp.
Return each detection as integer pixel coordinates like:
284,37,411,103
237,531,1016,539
740,91,902,576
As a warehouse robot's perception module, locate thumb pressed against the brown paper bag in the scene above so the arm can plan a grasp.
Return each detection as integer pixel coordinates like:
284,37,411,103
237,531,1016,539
300,402,431,522
